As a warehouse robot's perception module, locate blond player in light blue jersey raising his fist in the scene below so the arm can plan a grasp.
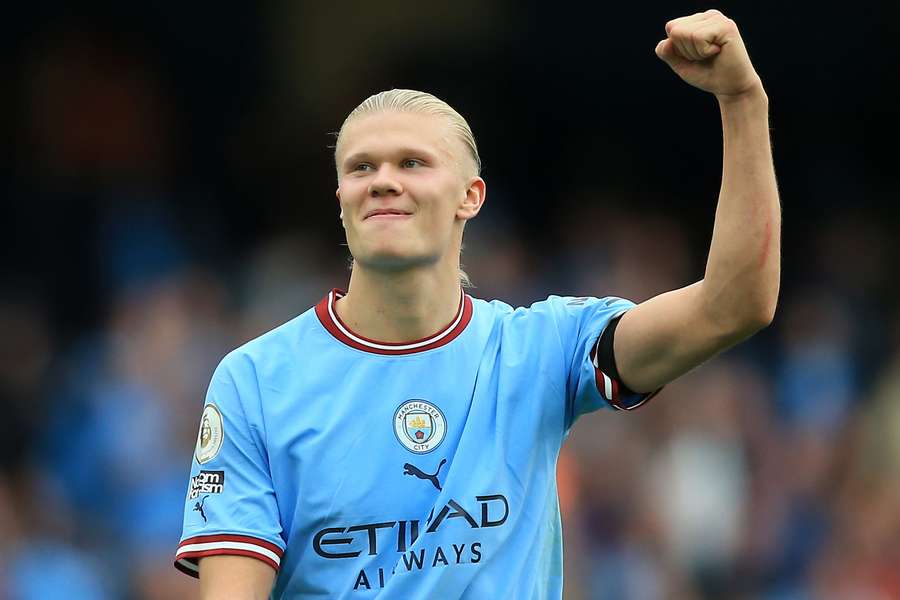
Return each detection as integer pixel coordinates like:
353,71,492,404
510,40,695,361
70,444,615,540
176,11,780,600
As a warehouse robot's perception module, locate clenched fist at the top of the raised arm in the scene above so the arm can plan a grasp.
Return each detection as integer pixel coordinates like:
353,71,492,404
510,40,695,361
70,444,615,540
656,10,762,98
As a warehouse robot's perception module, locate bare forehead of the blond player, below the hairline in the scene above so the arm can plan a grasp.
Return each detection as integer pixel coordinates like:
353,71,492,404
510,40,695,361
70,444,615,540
337,111,461,161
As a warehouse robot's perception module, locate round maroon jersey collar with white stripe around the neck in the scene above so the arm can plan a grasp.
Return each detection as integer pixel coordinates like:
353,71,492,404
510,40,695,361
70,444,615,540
316,288,472,355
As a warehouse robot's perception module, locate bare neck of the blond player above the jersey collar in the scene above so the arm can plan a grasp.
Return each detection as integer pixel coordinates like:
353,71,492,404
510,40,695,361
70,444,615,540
335,263,460,342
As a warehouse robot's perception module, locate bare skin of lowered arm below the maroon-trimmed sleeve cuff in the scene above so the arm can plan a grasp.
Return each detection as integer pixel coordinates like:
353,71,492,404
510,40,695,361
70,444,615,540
200,556,275,600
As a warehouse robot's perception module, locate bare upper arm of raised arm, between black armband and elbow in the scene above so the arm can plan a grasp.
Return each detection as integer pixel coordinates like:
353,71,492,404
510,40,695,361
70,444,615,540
613,281,766,392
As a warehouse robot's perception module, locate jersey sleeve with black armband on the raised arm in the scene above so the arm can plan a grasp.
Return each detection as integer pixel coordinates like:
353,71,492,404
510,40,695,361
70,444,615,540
548,296,658,428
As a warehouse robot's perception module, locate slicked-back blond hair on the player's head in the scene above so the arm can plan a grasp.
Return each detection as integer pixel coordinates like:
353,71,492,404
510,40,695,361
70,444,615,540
334,89,481,175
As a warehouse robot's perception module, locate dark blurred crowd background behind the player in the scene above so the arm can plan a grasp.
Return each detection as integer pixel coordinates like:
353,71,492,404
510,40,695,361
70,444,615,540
0,0,900,600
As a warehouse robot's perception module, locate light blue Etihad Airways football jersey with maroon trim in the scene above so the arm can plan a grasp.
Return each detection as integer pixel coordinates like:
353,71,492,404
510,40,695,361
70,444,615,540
175,290,649,600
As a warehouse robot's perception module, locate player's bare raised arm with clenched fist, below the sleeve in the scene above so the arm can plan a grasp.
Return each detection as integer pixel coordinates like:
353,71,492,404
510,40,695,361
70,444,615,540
614,10,781,392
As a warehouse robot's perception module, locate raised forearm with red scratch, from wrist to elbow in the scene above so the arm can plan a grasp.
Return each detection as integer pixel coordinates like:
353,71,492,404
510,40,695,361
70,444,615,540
702,86,781,333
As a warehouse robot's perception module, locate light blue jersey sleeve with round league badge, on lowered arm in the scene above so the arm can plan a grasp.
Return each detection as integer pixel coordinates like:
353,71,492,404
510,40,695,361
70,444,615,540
175,353,285,577
